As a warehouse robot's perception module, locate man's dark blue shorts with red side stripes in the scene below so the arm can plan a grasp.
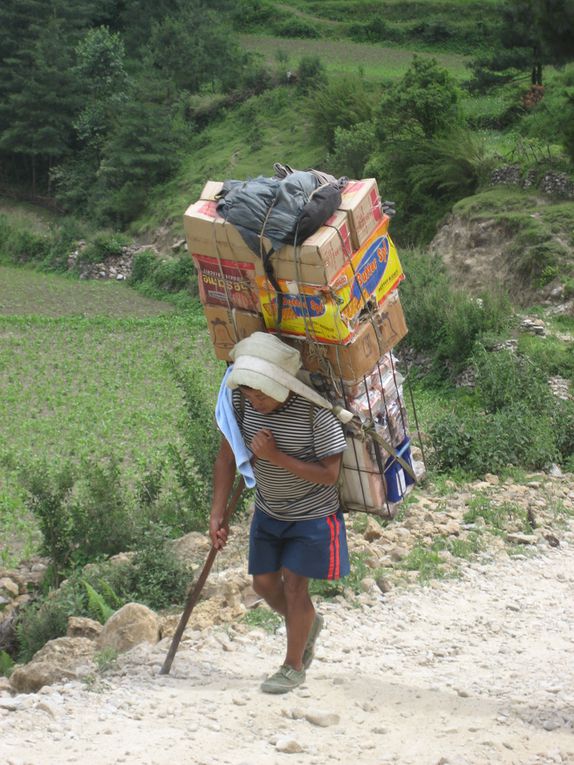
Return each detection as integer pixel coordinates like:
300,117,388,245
249,510,350,579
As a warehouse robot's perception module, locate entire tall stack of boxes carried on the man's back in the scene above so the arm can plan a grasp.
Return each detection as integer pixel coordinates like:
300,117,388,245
184,178,418,515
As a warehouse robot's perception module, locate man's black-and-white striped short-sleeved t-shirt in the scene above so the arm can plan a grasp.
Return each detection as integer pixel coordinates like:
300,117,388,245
233,390,347,521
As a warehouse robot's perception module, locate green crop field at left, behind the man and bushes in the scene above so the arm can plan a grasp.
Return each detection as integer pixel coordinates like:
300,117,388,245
0,267,221,561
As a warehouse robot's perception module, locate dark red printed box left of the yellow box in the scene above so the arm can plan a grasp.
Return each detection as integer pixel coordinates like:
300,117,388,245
193,255,259,313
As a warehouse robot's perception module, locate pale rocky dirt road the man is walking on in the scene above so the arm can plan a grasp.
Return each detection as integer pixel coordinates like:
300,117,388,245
0,532,574,765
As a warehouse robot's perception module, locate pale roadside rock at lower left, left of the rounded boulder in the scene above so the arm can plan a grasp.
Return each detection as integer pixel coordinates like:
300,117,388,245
10,637,96,693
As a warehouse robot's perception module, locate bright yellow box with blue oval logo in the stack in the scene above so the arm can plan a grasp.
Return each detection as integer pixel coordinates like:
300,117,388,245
257,226,403,344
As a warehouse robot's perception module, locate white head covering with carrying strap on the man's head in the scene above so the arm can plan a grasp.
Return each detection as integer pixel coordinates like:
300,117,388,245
227,332,353,422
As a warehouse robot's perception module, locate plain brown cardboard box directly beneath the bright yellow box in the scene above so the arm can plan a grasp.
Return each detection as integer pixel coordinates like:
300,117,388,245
292,290,408,385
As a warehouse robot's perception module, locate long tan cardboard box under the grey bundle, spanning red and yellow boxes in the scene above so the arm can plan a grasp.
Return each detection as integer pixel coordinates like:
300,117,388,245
183,181,355,284
